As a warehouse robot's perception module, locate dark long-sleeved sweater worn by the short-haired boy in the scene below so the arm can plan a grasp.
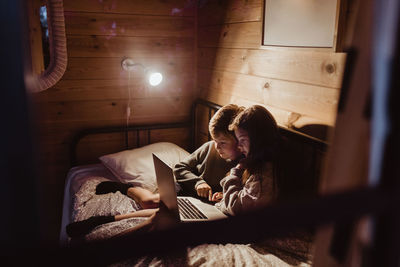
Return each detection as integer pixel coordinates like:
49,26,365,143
174,141,236,196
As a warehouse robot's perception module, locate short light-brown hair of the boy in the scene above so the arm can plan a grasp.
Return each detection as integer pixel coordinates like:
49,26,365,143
208,104,244,138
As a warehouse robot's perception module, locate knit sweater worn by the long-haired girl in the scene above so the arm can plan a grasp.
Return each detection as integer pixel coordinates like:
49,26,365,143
215,163,277,215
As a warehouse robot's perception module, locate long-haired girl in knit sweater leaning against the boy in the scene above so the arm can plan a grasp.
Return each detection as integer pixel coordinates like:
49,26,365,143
212,105,279,215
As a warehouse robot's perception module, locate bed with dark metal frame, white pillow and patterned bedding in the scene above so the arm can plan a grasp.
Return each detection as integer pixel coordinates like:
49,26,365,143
60,99,326,266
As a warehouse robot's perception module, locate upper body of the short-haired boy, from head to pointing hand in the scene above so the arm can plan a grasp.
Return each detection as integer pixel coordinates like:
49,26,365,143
174,104,244,201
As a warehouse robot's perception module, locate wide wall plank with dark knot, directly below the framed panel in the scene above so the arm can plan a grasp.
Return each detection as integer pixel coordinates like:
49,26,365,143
198,47,346,88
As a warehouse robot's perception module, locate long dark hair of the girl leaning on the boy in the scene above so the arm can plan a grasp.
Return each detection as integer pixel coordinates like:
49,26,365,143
229,105,279,169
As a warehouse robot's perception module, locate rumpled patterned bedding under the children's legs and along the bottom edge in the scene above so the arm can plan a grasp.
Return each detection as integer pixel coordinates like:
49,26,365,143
67,175,312,267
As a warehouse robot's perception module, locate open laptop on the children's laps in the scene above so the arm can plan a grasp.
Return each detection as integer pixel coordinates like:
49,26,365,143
153,153,227,222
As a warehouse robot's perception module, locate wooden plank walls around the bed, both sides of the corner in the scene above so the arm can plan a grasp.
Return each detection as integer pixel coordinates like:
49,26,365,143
27,0,345,245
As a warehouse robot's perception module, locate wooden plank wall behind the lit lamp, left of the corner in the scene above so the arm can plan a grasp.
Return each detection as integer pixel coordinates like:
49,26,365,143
32,0,196,243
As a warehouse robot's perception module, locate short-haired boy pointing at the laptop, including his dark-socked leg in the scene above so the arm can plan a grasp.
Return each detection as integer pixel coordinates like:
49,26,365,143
96,104,244,206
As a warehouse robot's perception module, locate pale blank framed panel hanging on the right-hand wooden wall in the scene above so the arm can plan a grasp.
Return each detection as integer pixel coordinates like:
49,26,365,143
263,0,339,48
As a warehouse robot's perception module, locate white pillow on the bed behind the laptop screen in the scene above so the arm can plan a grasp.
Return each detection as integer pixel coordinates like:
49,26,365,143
99,142,189,192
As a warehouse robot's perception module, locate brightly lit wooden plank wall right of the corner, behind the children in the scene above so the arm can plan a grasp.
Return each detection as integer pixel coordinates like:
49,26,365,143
197,0,345,141
